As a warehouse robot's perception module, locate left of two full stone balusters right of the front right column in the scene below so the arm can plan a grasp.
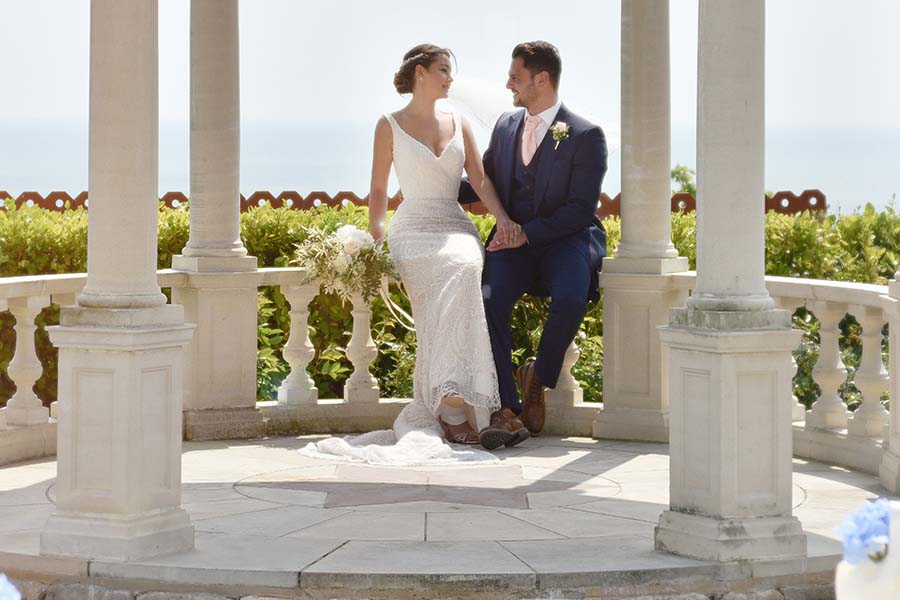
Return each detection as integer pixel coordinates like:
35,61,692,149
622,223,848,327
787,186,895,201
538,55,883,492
806,301,850,429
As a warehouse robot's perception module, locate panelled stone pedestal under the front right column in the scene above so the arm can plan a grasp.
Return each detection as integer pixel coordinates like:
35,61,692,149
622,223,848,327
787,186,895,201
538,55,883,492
656,309,806,562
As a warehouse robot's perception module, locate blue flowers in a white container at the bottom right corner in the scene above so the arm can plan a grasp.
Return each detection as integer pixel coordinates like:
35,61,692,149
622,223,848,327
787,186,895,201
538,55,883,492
834,498,900,600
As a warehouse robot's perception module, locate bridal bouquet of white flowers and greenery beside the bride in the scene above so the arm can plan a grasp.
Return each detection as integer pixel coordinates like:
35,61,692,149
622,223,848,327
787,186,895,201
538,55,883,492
293,225,393,302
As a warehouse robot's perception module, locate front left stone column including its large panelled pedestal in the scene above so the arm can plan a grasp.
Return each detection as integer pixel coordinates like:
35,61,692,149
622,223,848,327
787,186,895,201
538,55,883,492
40,0,194,561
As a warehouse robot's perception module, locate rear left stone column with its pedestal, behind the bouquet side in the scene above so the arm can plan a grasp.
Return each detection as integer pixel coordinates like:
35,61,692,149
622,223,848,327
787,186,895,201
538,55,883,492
172,0,265,440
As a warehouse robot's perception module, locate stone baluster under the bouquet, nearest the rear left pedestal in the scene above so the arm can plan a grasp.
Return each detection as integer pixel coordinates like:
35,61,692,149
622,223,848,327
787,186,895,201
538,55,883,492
278,285,319,405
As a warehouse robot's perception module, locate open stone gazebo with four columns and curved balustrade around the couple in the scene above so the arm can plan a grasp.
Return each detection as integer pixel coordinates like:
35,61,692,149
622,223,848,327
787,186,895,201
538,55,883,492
0,0,900,595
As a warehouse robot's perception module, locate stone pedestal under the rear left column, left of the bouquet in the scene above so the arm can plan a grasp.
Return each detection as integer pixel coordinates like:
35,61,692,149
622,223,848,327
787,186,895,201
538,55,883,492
172,270,265,440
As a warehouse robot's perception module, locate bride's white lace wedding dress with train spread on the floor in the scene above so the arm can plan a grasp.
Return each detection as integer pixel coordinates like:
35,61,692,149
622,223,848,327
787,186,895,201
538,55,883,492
300,114,500,465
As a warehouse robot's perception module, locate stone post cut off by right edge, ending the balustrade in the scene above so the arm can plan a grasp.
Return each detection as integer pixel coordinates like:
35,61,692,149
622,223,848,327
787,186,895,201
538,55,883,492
879,271,900,494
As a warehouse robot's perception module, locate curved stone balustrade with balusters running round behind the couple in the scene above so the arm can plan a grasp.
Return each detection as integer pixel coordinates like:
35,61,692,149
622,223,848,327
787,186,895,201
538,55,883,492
0,268,890,473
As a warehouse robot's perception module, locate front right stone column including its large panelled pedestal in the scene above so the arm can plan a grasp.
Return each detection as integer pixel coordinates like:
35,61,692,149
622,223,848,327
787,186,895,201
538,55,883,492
656,0,806,562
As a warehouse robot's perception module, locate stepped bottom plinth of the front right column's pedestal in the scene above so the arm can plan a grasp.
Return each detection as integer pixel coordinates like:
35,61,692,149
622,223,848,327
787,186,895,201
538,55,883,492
654,510,806,562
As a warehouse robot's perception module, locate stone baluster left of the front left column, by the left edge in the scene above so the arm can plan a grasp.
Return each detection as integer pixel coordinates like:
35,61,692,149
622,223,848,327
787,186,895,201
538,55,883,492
6,296,50,426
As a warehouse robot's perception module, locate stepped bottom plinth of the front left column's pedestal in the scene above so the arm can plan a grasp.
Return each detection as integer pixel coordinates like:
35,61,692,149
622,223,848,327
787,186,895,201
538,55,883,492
41,508,194,562
